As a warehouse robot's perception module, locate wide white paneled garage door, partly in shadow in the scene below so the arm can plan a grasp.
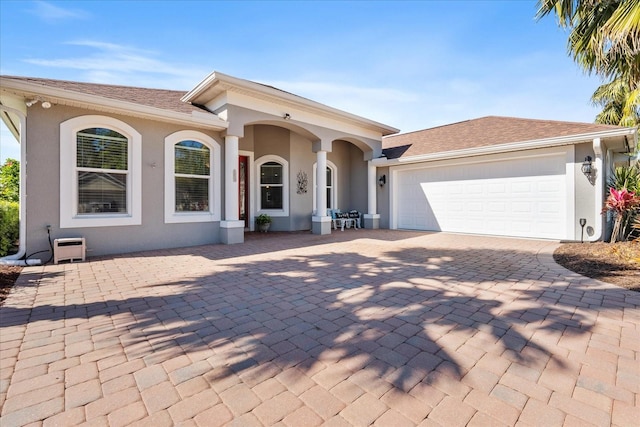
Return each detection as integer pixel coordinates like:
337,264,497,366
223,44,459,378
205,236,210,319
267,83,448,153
395,154,567,239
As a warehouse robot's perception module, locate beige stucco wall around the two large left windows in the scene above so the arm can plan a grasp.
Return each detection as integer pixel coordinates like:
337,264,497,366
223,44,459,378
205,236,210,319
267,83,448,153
26,105,224,256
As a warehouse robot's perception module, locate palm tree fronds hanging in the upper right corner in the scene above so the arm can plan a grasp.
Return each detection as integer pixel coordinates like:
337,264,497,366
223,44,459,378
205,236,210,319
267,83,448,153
536,0,640,126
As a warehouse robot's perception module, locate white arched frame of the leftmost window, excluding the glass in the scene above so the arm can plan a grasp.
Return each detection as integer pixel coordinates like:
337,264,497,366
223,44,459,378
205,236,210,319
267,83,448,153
60,115,142,228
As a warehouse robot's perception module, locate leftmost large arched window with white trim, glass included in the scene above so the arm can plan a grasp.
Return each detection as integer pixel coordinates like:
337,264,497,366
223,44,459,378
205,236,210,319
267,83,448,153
60,116,142,228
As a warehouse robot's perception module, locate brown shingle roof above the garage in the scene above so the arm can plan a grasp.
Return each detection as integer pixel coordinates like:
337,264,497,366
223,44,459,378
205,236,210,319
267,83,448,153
382,116,622,159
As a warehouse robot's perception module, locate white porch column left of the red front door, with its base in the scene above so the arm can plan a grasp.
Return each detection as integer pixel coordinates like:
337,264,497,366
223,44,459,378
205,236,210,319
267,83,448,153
220,135,244,245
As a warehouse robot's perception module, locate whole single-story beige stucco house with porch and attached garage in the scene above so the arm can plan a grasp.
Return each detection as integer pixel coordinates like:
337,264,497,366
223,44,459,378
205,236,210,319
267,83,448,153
0,72,637,258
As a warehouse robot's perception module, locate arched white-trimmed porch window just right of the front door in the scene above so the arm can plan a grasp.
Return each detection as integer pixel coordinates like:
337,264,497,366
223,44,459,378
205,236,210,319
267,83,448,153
256,155,289,216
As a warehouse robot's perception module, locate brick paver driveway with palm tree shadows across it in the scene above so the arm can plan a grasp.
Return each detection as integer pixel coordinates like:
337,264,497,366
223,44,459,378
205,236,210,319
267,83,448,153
0,230,640,427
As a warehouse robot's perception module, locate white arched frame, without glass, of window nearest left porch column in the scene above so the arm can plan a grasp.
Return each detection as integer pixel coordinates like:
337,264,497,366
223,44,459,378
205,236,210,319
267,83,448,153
164,130,221,224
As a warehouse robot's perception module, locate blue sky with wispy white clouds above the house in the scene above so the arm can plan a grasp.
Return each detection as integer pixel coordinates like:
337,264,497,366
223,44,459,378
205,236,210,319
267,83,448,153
0,0,600,161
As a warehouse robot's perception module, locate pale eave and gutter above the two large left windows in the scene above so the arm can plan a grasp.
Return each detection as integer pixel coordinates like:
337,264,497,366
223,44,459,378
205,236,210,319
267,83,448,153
0,77,228,130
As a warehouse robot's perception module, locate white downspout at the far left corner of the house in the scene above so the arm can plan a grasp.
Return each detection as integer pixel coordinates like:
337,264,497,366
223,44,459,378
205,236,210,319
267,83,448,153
0,105,41,266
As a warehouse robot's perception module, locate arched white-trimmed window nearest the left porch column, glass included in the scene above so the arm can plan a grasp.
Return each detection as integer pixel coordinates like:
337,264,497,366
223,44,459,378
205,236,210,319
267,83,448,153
165,131,220,223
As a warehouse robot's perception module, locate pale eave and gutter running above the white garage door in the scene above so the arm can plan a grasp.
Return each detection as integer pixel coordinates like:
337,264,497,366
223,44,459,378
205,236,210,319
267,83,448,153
373,128,638,166
